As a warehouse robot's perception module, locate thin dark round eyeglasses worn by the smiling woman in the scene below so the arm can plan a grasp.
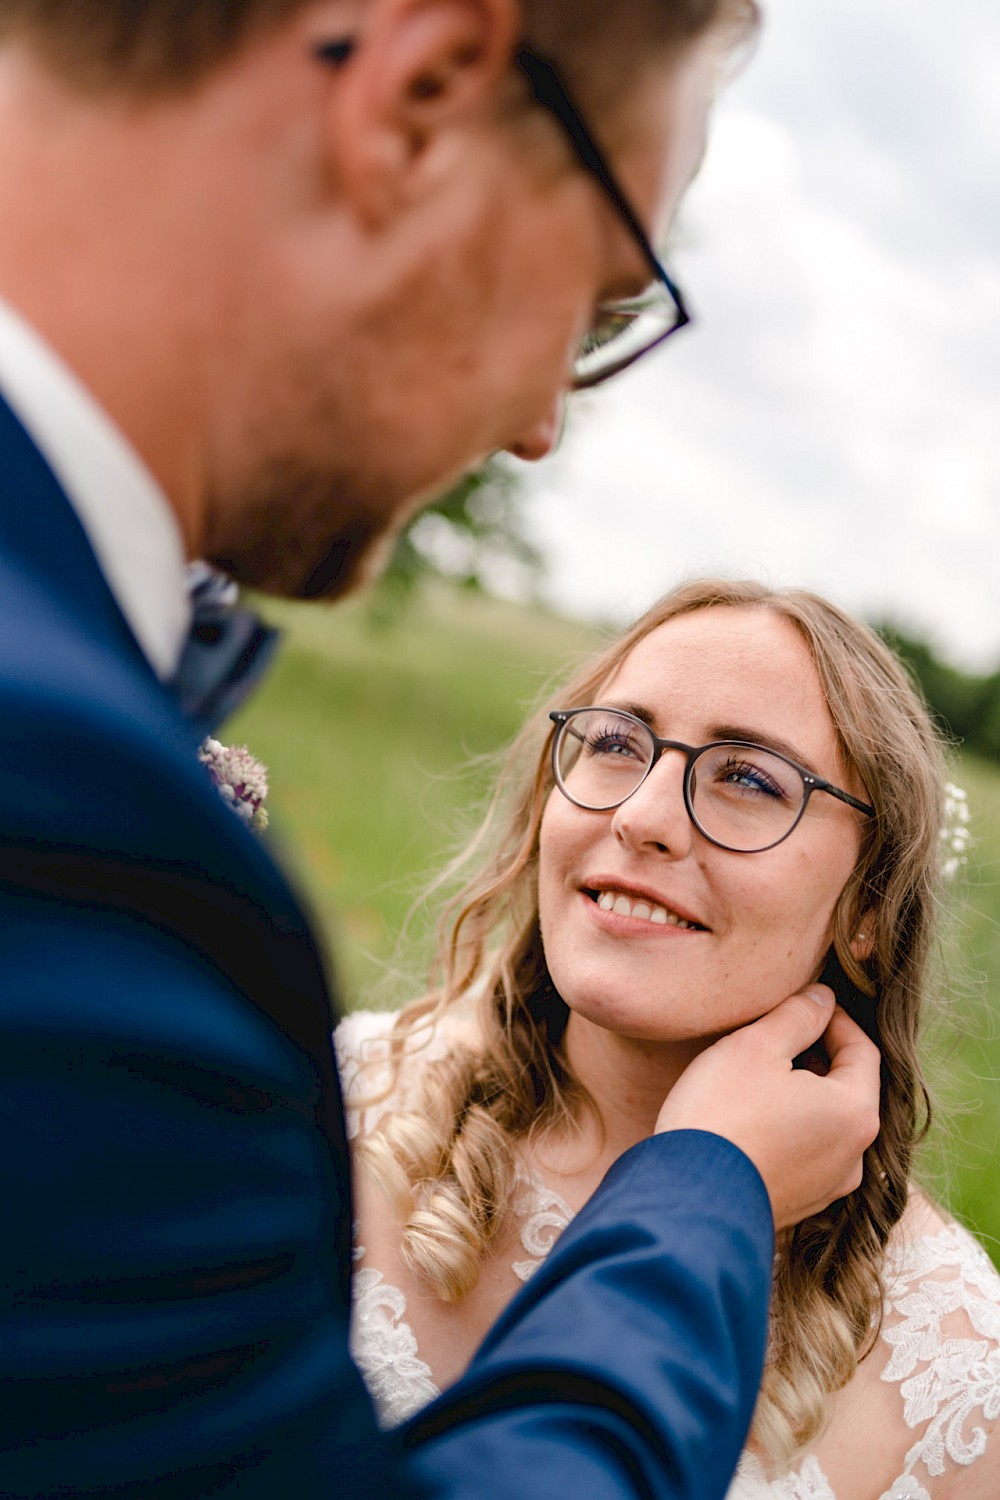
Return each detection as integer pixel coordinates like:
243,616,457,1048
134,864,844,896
549,708,876,854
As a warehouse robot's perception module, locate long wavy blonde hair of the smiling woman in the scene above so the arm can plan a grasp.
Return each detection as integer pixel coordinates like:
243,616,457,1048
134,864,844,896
363,579,946,1464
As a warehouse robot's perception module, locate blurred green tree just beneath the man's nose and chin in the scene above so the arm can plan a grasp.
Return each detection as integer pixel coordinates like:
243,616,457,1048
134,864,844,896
369,458,544,624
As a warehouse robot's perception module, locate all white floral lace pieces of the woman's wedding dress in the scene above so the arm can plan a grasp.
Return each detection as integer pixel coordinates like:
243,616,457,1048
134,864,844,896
336,1013,1000,1500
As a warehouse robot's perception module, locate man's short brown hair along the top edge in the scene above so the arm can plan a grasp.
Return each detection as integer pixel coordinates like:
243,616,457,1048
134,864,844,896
0,0,756,95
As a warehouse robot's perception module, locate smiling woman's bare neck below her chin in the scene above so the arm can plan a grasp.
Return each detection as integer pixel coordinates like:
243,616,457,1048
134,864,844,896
540,1014,709,1176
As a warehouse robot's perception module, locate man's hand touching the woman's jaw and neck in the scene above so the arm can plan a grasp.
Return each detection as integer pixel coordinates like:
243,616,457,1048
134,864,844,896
657,984,879,1229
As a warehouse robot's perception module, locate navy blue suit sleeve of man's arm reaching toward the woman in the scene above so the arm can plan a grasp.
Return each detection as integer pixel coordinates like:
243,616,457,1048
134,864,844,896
403,1131,774,1500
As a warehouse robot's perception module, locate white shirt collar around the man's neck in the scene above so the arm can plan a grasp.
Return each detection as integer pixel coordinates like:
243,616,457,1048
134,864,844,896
0,299,190,681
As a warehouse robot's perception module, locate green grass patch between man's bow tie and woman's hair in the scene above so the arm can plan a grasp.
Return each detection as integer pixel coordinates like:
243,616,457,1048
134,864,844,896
225,587,600,1005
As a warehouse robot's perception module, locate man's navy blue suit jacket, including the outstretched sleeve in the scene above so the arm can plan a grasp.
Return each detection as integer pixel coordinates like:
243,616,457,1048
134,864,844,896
0,402,772,1500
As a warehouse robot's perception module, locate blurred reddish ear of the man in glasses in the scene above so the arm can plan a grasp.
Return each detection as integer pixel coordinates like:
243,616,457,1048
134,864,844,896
325,0,520,228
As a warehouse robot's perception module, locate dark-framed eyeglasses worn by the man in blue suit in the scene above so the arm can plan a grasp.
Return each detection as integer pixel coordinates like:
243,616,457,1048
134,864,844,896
316,38,691,390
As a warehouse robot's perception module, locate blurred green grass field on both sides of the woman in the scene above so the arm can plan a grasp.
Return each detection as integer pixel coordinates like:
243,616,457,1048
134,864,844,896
225,585,1000,1263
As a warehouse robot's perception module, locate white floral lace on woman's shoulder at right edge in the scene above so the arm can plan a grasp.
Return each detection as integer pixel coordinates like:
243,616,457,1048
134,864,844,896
880,1220,1000,1500
